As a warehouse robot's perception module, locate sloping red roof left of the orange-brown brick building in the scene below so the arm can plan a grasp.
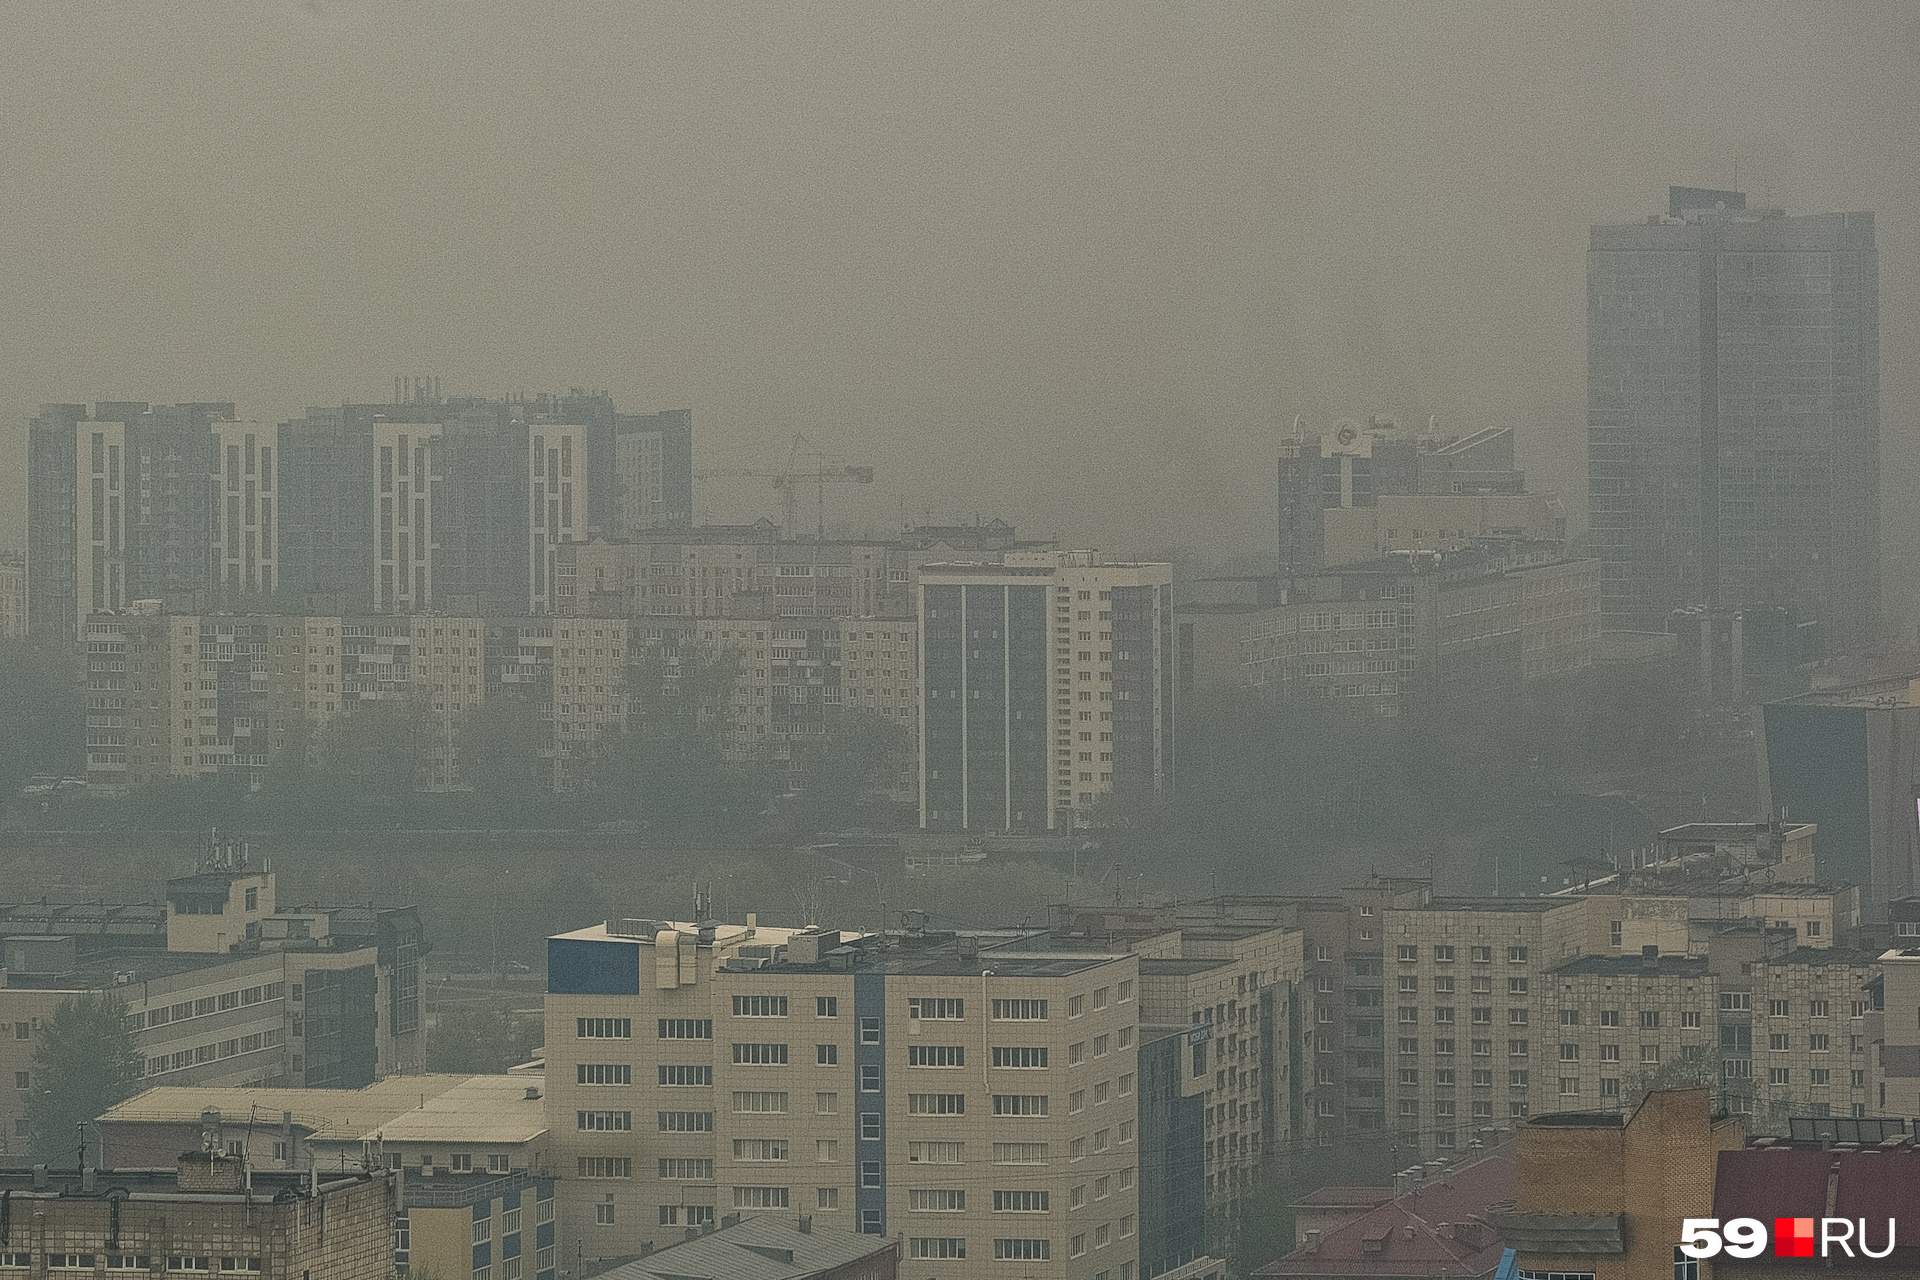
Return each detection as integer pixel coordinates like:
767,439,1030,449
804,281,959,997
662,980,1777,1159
1254,1148,1513,1276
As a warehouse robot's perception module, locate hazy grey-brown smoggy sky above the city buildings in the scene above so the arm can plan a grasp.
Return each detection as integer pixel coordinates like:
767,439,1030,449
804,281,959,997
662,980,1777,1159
0,0,1920,594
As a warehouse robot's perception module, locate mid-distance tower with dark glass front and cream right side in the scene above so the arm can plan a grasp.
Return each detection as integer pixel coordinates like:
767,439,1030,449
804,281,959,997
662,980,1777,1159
920,551,1175,831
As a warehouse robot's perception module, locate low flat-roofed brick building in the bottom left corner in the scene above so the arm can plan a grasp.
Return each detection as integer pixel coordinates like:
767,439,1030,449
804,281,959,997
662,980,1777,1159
0,1151,399,1280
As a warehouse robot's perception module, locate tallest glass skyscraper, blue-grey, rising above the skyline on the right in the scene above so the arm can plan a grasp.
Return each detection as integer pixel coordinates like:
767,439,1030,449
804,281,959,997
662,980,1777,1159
1588,186,1880,652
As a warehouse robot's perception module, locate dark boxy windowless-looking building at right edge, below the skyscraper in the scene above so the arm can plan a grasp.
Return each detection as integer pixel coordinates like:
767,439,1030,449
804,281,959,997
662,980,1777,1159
1761,679,1920,923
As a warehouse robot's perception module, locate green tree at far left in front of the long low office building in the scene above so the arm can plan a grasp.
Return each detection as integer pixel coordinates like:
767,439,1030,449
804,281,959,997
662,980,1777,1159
27,992,140,1165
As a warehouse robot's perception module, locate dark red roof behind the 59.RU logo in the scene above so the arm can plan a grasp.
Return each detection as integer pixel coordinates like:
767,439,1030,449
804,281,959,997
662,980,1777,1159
1713,1146,1920,1267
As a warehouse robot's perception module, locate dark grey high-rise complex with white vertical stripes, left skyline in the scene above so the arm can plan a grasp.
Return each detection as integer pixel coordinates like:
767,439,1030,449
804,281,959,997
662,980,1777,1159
27,380,693,637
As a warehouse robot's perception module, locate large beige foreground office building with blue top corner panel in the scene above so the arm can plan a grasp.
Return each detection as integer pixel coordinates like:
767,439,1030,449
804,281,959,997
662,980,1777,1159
547,917,1142,1280
